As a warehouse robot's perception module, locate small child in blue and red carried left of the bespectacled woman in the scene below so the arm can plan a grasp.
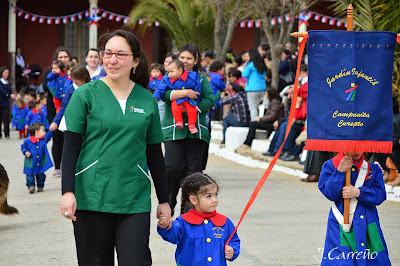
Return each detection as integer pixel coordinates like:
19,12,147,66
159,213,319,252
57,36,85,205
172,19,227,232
47,60,68,113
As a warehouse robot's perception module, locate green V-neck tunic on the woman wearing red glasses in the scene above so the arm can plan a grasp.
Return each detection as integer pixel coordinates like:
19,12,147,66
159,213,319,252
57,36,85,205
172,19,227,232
65,80,163,214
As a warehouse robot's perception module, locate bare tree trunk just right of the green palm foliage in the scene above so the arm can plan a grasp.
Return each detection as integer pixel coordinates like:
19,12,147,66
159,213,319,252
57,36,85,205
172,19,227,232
206,0,254,61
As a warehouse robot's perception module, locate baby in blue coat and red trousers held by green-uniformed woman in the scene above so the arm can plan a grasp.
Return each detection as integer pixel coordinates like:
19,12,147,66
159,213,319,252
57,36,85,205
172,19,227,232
154,59,201,134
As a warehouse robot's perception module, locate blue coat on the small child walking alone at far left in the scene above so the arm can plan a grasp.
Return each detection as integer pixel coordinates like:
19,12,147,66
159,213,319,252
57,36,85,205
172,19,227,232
21,131,54,175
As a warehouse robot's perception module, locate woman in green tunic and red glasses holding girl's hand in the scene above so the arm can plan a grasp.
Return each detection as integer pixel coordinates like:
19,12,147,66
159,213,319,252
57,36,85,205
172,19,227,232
60,30,171,265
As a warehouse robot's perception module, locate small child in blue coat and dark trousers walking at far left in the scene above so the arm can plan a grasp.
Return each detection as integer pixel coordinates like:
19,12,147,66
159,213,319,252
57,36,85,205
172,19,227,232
21,123,54,194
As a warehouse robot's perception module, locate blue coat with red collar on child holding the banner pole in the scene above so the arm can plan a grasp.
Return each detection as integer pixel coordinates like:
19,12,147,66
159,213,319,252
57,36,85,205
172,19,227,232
318,153,391,265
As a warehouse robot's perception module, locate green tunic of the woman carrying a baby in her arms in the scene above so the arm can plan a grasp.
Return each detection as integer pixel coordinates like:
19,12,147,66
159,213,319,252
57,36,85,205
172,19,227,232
162,74,215,143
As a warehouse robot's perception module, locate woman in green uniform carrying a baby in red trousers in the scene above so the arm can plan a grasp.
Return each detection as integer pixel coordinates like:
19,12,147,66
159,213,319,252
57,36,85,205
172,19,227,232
162,44,214,215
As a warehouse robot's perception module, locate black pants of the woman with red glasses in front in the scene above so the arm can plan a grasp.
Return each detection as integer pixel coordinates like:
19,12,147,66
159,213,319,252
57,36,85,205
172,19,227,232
73,210,152,266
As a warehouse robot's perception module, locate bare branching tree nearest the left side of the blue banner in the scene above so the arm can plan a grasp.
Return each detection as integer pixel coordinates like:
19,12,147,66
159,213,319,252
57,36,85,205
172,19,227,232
254,0,317,88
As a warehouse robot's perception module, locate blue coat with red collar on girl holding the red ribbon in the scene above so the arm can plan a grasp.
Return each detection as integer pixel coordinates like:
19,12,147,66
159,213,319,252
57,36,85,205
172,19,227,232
157,209,240,266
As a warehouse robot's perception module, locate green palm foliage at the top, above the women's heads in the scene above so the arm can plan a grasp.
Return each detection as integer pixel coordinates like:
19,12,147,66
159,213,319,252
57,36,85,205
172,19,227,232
129,0,214,51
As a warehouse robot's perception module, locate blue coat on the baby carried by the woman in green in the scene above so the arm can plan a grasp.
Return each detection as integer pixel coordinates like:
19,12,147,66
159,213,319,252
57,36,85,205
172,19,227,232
154,70,201,106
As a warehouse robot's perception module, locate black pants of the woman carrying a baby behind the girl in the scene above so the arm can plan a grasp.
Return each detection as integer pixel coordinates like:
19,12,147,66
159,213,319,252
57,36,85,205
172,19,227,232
164,138,207,213
